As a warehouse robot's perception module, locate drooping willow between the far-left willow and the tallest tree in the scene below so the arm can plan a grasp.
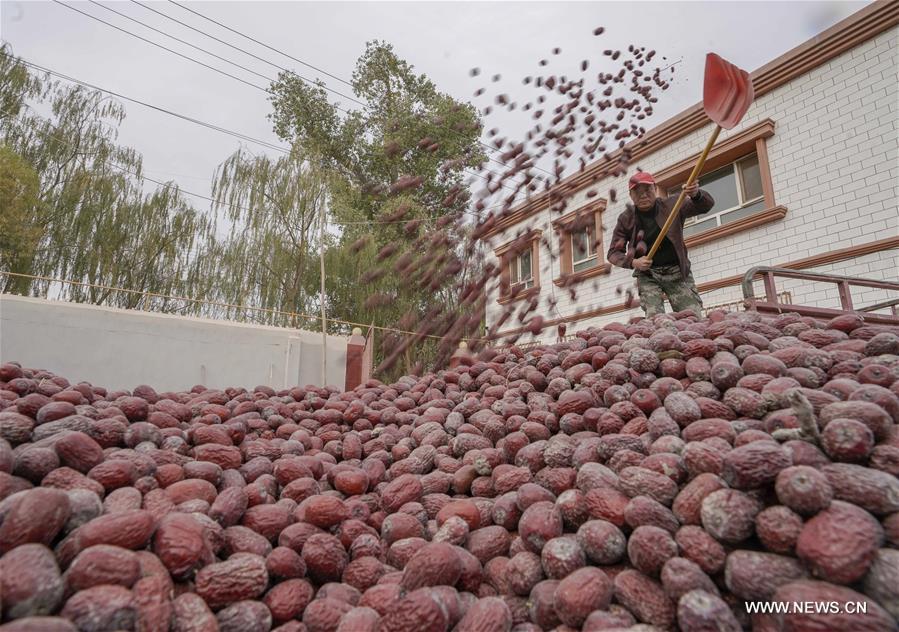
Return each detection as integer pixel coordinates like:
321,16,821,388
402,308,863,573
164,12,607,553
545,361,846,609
206,149,328,327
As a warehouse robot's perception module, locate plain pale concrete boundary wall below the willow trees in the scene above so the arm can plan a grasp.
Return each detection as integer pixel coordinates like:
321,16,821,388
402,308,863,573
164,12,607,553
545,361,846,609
0,294,347,391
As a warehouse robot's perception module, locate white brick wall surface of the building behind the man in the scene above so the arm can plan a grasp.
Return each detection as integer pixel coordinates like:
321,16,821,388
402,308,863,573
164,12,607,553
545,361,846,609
487,27,899,342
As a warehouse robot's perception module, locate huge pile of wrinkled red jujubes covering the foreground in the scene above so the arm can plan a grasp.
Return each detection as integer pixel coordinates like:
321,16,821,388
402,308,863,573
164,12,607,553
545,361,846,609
0,312,899,632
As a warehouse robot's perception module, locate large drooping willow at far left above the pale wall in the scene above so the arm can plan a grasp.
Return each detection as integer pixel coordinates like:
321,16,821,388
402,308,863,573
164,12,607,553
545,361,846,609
0,47,214,312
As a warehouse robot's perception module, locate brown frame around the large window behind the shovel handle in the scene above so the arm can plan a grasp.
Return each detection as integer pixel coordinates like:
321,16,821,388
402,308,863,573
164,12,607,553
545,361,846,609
655,119,787,248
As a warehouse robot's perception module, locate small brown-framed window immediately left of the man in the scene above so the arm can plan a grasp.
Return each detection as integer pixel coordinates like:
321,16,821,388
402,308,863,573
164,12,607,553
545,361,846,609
553,200,611,286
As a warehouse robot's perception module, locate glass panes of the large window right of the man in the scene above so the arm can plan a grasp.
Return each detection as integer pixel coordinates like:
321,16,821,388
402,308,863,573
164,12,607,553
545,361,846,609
669,154,765,237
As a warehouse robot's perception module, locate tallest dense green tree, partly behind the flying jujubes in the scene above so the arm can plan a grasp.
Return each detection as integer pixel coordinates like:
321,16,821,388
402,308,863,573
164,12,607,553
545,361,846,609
271,42,483,378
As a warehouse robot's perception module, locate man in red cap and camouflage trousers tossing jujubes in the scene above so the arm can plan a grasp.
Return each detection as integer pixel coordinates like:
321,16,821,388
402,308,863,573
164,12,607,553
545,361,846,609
606,171,715,318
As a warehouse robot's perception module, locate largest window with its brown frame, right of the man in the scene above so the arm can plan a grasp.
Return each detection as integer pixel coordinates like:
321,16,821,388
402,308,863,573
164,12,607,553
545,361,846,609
654,119,787,248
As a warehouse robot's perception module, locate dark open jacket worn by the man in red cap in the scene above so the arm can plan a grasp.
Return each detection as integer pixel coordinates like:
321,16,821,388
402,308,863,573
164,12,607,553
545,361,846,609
606,190,715,279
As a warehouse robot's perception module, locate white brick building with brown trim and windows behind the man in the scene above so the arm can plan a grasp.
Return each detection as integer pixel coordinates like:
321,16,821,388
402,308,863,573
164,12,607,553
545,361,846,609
484,2,899,343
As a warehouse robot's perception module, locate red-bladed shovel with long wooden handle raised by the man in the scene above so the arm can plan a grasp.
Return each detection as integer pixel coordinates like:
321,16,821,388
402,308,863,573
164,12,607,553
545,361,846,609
646,53,755,259
